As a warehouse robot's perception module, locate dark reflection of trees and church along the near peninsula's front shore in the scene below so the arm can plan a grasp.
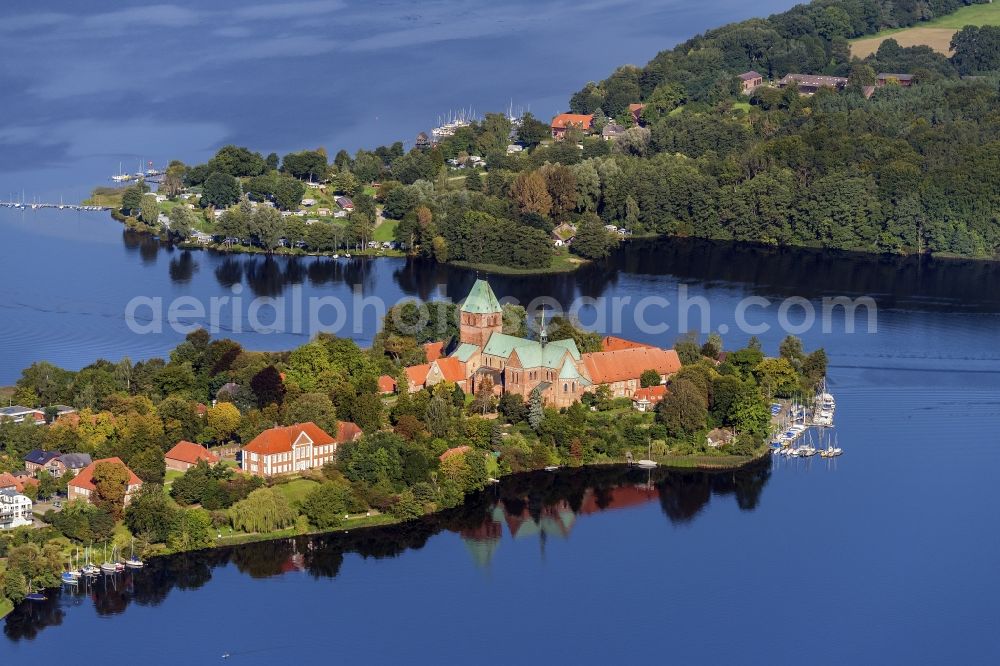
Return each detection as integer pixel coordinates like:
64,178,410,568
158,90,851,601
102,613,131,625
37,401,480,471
4,460,771,640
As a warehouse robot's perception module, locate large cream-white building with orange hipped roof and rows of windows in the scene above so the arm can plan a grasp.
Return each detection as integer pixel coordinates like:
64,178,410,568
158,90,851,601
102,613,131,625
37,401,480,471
240,421,361,477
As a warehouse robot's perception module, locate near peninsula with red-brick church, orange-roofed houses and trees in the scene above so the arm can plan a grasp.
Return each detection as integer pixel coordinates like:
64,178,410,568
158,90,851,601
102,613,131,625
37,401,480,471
0,280,826,612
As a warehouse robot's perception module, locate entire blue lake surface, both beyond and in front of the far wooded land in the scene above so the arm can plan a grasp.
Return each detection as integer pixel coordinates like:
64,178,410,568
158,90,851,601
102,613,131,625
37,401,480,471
0,0,1000,664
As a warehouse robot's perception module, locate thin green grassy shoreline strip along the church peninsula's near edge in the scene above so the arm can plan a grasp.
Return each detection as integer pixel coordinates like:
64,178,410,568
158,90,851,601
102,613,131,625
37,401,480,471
0,447,771,620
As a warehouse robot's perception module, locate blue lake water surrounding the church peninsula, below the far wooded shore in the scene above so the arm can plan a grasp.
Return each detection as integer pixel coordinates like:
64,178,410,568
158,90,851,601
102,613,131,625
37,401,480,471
0,211,1000,664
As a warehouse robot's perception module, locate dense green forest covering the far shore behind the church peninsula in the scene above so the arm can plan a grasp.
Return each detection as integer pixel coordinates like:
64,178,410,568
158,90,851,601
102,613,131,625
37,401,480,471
122,0,1000,270
